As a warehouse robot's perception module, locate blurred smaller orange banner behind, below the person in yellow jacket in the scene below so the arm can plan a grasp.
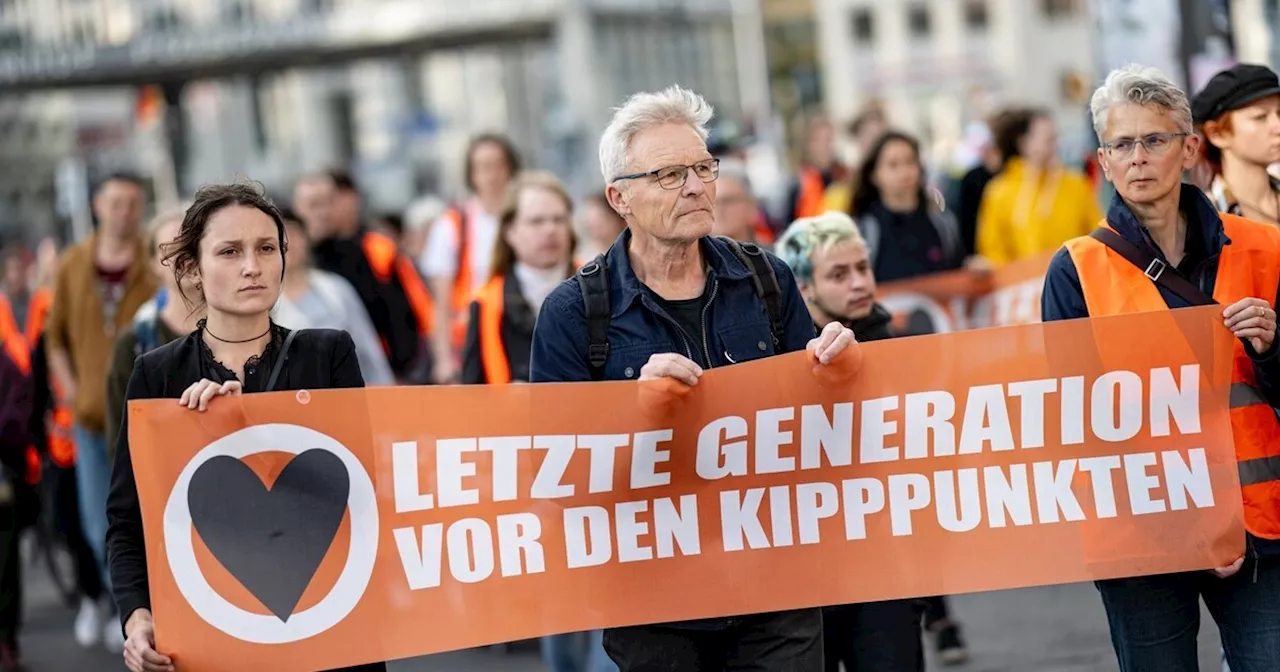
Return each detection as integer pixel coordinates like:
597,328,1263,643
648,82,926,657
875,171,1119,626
878,253,1053,335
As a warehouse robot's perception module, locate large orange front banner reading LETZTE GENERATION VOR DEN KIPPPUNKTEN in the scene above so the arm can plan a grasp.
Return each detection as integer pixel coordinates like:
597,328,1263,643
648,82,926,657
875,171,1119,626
129,307,1244,672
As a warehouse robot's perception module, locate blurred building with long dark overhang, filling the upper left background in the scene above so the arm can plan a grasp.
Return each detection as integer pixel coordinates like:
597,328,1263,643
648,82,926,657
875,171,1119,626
0,0,769,241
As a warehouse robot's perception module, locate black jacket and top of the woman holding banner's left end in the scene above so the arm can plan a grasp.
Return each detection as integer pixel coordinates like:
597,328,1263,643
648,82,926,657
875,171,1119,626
106,321,380,668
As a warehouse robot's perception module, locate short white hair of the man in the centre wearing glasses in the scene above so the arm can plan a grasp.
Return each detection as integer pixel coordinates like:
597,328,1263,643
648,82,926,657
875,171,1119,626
600,84,716,183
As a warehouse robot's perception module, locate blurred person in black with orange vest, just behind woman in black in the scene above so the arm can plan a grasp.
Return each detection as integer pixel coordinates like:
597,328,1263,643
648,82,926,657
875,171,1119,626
293,170,435,384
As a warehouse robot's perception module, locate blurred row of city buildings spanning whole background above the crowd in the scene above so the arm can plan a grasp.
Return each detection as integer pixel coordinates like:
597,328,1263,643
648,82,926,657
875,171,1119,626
0,0,1280,244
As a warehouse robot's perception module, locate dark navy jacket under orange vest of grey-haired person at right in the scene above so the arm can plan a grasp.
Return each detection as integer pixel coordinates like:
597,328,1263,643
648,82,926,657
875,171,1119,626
1041,184,1280,557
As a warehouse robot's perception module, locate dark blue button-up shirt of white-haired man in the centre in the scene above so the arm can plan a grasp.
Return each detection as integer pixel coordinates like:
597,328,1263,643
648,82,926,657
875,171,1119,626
529,229,814,383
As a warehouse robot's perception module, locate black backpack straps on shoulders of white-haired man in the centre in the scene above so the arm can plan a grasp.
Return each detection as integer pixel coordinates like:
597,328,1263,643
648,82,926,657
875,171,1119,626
573,236,782,380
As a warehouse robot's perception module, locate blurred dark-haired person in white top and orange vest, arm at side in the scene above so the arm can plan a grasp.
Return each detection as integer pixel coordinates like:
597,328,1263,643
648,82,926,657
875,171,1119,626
420,134,520,383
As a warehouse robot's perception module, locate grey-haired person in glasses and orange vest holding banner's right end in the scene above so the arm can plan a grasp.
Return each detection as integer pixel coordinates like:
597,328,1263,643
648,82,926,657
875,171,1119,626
1042,65,1280,672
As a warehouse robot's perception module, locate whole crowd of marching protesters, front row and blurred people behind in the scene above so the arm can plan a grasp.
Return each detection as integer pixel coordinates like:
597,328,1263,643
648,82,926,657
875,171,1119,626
0,56,1280,672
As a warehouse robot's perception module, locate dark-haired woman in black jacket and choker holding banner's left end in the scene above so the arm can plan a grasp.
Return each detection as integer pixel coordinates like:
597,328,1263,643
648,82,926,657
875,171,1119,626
106,184,385,672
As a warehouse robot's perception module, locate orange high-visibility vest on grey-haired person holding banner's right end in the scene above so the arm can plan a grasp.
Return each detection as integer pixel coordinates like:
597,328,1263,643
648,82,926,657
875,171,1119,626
1066,214,1280,539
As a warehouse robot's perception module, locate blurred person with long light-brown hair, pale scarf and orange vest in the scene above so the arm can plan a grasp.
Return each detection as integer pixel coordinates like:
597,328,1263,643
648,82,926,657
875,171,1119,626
461,173,576,385
